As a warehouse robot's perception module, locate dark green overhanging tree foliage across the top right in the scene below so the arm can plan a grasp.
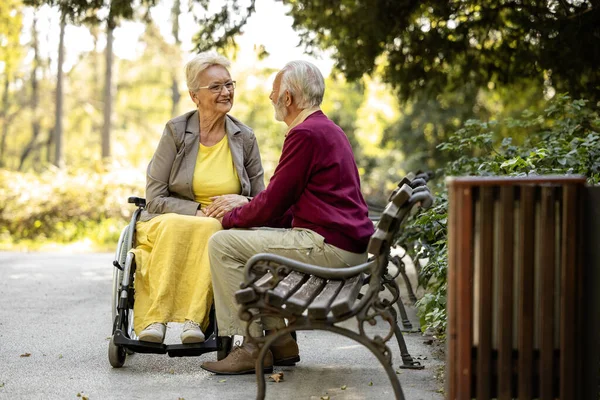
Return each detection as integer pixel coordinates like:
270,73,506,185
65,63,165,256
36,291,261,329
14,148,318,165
282,0,600,101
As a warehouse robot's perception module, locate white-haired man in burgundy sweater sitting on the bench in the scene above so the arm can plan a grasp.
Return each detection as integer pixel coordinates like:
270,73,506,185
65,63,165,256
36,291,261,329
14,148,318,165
202,61,373,374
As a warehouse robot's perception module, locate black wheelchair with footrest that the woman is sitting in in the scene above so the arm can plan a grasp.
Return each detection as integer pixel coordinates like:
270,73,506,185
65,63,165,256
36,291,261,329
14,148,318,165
108,197,232,368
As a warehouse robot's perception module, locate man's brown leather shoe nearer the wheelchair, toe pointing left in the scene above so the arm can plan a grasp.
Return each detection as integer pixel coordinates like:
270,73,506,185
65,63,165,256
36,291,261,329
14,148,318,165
201,344,273,375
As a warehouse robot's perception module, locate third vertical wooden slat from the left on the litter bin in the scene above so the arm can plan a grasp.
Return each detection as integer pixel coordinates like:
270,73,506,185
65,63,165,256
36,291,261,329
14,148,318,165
497,186,515,400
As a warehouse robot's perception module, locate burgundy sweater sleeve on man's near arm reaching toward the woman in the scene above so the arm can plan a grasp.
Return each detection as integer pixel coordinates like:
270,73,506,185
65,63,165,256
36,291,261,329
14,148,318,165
222,129,314,229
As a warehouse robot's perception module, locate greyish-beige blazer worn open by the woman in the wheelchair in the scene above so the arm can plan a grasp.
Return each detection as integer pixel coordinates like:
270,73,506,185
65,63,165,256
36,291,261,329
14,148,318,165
140,110,265,221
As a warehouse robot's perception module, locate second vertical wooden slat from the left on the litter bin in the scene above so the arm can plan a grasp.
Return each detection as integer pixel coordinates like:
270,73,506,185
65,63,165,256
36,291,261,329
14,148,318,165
475,187,494,400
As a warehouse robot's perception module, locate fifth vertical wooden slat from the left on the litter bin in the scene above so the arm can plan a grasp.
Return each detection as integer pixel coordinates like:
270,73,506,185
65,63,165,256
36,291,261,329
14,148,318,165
538,186,556,400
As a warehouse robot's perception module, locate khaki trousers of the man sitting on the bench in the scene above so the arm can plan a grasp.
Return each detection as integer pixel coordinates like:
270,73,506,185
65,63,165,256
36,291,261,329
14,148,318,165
208,228,367,337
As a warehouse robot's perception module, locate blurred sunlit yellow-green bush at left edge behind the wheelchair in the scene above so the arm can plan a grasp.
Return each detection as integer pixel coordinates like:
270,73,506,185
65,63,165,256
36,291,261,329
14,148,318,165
0,166,144,249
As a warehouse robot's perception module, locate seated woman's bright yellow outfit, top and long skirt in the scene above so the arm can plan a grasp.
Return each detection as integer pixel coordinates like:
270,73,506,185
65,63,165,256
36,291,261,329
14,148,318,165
132,136,241,333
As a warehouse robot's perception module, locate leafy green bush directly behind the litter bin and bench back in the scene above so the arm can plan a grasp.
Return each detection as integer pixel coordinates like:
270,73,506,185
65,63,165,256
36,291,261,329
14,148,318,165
397,95,600,334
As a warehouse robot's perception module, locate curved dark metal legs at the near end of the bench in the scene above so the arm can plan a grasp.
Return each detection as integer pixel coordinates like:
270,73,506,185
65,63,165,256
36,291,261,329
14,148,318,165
251,326,406,400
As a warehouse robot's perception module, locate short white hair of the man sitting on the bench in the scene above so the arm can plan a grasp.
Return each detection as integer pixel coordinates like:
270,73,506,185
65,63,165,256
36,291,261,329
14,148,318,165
279,60,325,109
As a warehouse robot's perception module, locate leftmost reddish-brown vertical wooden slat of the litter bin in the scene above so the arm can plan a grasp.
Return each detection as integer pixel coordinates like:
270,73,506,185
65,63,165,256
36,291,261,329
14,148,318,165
456,187,473,400
